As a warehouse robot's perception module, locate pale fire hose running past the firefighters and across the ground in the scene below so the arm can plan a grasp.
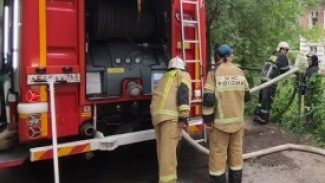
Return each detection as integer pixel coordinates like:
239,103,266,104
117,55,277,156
182,68,325,160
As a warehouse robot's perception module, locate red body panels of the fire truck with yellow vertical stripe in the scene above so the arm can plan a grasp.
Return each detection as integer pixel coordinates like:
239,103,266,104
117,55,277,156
8,0,207,156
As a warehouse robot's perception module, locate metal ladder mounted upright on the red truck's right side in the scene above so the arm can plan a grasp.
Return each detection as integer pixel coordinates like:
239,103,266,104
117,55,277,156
179,0,207,142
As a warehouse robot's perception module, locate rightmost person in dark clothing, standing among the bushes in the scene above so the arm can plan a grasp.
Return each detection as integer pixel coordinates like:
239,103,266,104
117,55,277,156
300,54,319,124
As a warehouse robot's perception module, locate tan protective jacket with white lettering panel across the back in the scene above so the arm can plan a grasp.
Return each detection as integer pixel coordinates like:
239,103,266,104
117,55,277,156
203,63,249,133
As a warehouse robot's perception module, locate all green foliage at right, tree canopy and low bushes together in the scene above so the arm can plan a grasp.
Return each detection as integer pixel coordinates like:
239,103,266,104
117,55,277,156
206,0,325,139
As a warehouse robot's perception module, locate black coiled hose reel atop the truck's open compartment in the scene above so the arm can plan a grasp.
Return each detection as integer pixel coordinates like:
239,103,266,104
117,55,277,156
88,0,158,41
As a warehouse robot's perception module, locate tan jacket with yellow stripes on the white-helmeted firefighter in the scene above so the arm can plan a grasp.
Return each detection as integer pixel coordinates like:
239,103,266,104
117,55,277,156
150,69,192,125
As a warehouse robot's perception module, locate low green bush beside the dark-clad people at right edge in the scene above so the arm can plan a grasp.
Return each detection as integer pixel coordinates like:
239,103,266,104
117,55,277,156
271,75,325,140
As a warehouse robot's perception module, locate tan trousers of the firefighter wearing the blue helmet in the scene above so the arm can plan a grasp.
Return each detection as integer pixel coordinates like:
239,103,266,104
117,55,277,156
209,128,243,177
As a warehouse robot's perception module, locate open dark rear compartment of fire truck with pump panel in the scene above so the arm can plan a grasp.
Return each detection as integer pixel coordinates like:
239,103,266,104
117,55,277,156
81,0,171,135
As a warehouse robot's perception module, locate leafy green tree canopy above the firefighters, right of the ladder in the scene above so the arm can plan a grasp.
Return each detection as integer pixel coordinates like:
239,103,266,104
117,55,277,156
206,0,321,66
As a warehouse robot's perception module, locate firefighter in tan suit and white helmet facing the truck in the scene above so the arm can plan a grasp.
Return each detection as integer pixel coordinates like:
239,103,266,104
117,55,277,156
150,57,192,183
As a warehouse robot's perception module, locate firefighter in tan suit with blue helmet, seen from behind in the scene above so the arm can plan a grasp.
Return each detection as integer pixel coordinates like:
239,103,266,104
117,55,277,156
202,44,249,183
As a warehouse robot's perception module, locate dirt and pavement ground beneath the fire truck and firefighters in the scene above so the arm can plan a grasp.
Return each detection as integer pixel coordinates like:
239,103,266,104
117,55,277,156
0,122,325,183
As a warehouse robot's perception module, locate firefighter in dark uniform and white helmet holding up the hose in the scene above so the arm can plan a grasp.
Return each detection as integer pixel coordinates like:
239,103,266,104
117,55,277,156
253,42,290,124
